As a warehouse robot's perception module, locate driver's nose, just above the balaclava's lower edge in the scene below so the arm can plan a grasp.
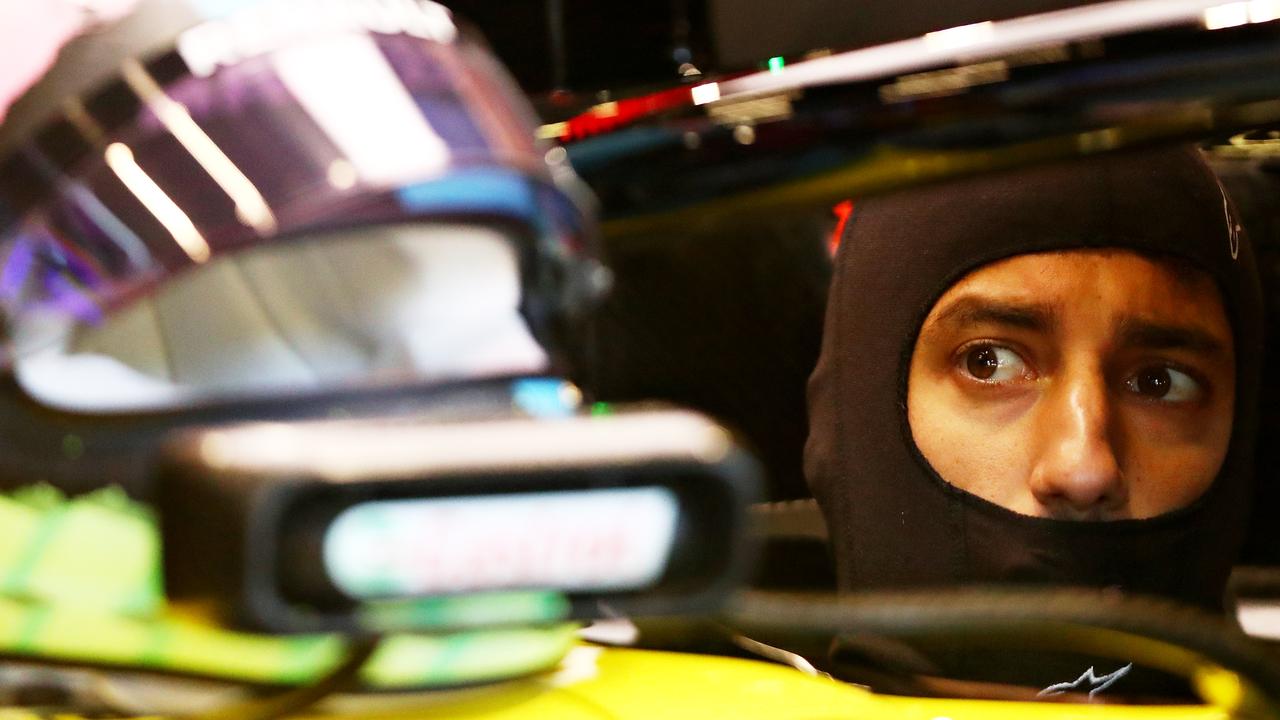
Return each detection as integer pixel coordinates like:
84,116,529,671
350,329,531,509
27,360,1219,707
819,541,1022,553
1029,370,1128,520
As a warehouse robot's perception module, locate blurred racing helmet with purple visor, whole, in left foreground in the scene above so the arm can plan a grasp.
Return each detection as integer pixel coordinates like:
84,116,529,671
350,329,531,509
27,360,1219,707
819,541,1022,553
0,0,607,492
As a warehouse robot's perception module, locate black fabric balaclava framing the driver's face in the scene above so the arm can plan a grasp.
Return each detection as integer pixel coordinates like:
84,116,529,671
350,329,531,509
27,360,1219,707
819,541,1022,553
805,147,1262,611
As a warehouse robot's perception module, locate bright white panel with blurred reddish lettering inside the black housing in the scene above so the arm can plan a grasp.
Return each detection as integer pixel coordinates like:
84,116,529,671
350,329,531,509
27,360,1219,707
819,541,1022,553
323,487,680,600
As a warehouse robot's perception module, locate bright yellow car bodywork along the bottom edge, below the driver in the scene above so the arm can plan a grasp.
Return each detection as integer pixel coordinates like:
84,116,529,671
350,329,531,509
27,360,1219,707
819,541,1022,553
296,646,1231,720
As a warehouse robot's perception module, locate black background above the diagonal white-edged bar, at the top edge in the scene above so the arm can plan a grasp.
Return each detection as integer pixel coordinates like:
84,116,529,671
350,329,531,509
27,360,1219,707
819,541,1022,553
447,0,1111,95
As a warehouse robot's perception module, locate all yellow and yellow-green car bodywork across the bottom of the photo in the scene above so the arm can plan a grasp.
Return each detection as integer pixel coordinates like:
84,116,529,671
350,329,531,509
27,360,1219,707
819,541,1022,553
0,487,1265,720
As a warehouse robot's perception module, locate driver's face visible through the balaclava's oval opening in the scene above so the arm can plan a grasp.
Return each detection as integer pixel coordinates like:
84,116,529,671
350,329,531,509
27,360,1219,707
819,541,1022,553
908,250,1235,520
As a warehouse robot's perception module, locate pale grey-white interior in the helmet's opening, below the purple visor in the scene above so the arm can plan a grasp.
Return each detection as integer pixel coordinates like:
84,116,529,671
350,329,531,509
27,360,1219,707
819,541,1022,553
14,224,548,413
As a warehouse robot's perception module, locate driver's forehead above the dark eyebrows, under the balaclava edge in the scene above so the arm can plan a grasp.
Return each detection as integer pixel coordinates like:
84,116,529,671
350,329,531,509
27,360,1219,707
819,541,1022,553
929,250,1229,328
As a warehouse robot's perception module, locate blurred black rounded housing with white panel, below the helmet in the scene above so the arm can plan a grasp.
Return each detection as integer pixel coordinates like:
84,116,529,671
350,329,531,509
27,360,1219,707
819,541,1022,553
157,409,762,633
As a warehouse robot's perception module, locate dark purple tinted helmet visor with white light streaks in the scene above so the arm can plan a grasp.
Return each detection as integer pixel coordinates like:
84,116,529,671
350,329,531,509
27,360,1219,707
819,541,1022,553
0,33,582,404
